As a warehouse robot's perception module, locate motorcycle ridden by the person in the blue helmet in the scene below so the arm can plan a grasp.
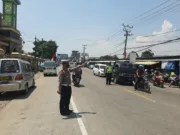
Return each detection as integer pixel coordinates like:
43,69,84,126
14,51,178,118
137,77,151,93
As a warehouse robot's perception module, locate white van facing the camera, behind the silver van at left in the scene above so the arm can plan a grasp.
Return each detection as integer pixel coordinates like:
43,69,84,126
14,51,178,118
43,61,57,76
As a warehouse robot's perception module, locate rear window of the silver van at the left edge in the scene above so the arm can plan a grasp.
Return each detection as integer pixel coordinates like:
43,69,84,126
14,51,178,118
0,60,19,73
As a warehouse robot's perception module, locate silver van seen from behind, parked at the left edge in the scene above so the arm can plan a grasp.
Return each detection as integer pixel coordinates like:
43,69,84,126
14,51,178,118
0,58,35,93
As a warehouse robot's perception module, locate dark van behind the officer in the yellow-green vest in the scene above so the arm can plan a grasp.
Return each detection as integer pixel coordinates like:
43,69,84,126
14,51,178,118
112,61,136,84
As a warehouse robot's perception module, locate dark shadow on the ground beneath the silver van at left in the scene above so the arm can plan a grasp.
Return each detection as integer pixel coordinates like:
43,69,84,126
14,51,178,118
0,87,36,101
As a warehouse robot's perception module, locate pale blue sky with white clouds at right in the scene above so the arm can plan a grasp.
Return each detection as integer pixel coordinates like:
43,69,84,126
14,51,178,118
0,0,180,57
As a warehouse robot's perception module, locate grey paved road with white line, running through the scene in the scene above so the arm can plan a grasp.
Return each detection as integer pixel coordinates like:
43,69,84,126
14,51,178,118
0,68,180,135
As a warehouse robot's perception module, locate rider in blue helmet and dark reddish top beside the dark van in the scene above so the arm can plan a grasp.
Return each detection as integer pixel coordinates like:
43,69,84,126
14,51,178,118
135,65,144,90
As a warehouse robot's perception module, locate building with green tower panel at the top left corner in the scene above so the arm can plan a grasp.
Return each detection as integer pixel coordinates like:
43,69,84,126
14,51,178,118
0,0,23,54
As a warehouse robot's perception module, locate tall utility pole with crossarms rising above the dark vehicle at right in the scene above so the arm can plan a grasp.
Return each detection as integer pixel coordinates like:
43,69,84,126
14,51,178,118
123,24,133,58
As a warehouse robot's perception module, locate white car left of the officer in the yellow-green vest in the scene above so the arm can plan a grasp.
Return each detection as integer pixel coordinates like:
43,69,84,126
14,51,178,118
93,64,107,76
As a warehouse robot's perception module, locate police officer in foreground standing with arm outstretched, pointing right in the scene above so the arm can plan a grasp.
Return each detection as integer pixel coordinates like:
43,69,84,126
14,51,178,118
57,61,83,116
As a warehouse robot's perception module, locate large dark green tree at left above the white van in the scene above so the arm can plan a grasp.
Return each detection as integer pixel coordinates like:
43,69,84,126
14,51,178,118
33,40,58,59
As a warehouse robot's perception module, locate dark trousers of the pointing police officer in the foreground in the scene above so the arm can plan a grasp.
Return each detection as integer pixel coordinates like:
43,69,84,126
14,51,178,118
60,86,72,113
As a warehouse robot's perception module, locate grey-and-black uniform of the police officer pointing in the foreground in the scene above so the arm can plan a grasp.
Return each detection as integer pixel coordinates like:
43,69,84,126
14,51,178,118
59,69,74,114
